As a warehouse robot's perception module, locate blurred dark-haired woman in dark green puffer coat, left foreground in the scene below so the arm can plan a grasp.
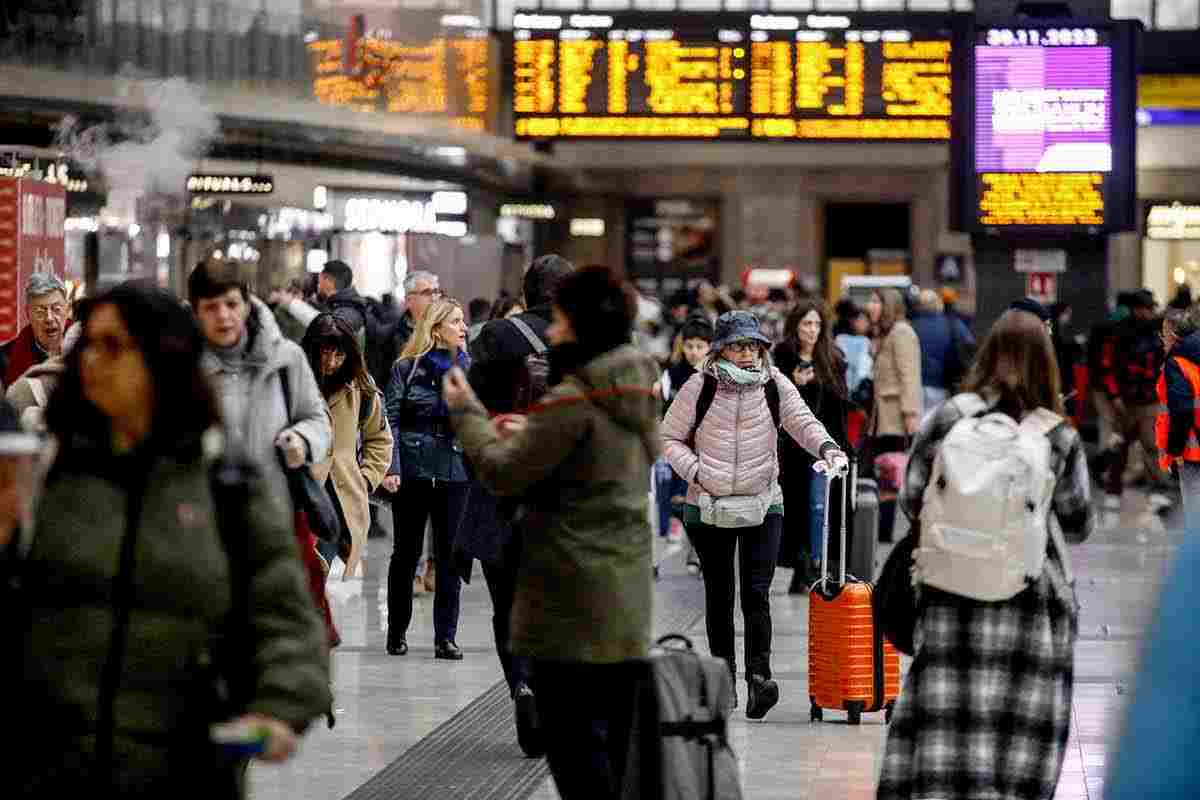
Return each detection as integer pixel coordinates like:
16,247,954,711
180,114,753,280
5,284,329,798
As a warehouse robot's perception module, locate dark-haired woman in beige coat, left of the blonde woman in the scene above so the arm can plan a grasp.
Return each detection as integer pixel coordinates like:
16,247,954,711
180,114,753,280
300,313,392,579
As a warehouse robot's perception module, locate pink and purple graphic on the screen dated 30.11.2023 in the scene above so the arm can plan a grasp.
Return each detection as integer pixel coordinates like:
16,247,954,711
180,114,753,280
974,46,1112,173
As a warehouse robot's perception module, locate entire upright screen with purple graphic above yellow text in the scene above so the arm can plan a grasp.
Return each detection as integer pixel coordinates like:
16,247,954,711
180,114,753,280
959,25,1134,230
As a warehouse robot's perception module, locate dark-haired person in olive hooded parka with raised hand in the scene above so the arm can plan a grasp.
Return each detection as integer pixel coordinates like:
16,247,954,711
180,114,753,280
445,266,659,800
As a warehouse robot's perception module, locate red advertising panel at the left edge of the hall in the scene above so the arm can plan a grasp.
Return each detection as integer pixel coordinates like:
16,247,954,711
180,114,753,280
0,178,67,342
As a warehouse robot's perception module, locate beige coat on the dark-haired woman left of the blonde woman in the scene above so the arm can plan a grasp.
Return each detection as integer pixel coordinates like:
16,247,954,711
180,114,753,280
312,384,391,578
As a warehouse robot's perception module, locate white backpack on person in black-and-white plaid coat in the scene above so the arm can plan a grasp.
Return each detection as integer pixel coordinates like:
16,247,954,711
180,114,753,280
913,395,1070,602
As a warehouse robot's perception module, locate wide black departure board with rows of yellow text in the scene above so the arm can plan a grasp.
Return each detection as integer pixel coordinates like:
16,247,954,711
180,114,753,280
512,12,953,142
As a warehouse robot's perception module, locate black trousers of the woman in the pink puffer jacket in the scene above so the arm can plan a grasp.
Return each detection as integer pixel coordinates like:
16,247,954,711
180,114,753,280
688,513,784,678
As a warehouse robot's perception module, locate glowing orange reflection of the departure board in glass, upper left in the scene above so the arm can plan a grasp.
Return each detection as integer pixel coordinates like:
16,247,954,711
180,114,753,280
308,29,492,130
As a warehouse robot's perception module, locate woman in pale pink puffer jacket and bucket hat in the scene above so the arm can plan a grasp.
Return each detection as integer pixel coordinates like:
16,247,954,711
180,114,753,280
662,311,847,720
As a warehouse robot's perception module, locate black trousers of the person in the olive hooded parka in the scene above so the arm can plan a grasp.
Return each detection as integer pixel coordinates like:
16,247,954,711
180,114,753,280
534,658,634,800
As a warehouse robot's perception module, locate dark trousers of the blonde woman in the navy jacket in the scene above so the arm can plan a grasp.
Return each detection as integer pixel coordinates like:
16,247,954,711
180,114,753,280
388,479,467,644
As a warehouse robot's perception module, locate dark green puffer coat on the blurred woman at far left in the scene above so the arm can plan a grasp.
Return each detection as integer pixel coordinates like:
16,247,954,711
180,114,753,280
12,440,330,798
